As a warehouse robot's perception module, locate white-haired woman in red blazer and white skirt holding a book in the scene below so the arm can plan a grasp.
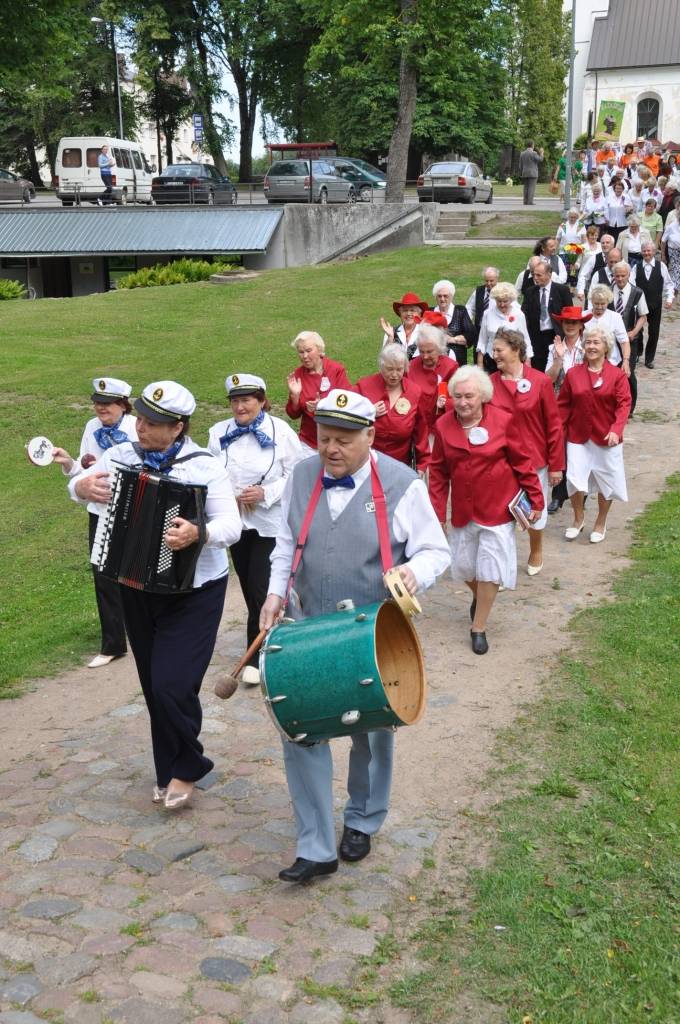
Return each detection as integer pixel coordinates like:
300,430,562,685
429,367,545,654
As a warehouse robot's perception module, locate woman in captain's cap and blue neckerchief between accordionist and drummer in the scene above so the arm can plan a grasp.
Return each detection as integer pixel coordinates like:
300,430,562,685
208,374,304,683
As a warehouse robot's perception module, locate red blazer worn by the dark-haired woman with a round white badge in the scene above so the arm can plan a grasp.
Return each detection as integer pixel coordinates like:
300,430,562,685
490,366,566,473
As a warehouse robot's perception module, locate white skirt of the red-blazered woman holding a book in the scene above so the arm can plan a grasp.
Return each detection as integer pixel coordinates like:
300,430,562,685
449,521,517,590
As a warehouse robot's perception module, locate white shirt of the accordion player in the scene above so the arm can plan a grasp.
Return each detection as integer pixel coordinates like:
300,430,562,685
69,437,242,588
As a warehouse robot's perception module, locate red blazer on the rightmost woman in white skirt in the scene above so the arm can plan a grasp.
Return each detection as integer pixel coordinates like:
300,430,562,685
557,359,632,447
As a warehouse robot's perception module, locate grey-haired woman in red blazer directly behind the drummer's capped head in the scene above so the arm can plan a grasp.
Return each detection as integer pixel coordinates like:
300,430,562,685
356,343,430,473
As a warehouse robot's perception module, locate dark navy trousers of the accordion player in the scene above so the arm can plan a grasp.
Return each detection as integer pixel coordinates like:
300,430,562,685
121,577,227,786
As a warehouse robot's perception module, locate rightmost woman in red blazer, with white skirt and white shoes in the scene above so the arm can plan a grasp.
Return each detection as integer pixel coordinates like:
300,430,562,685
557,327,631,544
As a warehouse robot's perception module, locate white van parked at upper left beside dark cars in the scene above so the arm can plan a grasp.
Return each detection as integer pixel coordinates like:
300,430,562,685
53,135,154,206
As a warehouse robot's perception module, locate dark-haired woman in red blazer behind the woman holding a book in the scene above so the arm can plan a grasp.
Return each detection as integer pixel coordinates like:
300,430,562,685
491,328,565,575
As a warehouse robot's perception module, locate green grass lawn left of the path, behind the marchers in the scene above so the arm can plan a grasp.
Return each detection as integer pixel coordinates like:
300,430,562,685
0,247,526,695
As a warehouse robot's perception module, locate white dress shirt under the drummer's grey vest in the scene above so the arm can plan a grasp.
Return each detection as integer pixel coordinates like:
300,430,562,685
269,452,451,598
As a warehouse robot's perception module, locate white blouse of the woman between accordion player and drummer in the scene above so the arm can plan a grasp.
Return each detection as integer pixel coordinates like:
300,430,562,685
208,413,305,537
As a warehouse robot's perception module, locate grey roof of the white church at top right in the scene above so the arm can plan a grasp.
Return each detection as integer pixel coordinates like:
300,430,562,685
588,0,680,71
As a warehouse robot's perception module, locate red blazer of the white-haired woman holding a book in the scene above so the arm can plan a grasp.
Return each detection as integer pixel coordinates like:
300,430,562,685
430,402,543,527
